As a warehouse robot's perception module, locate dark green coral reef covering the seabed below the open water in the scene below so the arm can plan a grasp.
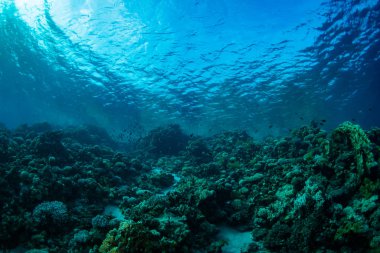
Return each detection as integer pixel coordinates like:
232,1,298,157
0,122,380,253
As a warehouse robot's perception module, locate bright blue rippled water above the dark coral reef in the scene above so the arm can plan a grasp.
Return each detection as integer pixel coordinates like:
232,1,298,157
0,0,380,135
